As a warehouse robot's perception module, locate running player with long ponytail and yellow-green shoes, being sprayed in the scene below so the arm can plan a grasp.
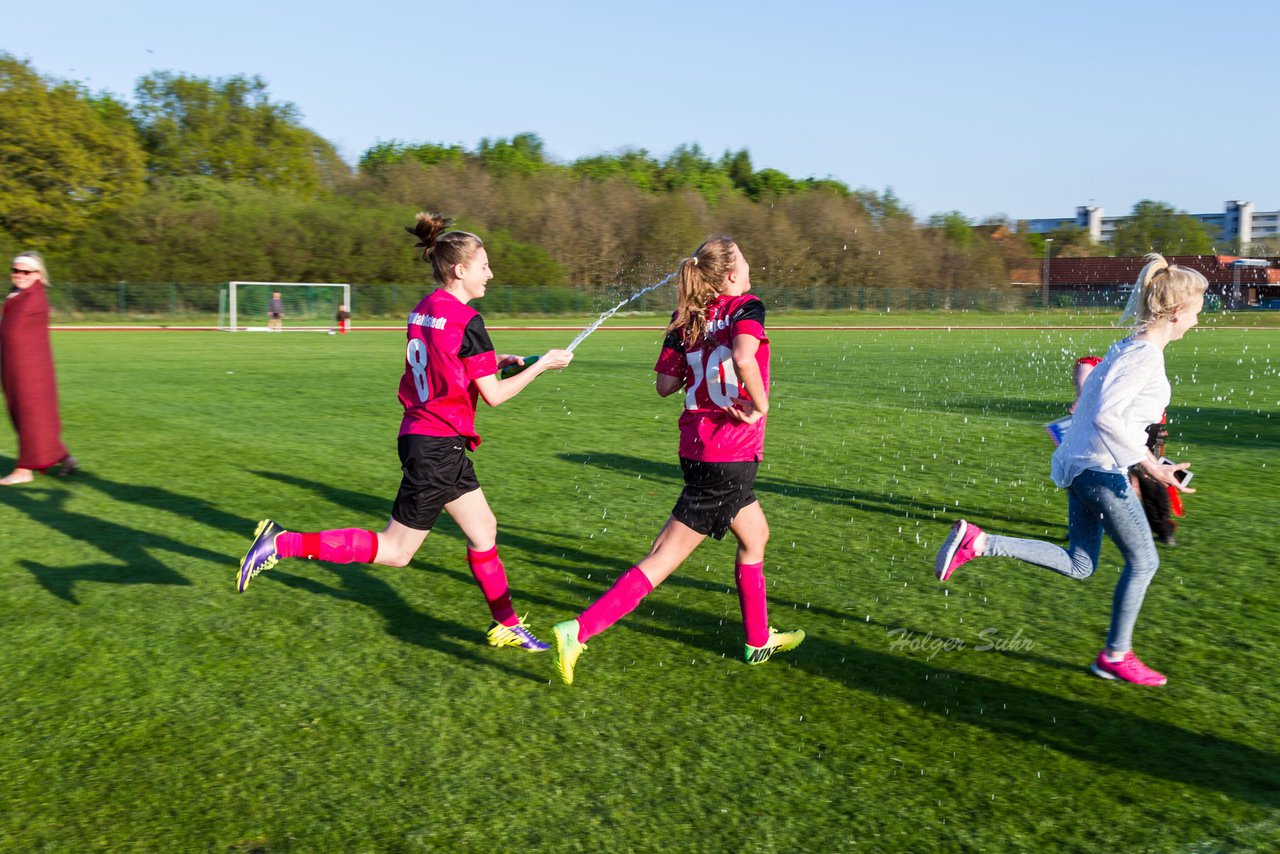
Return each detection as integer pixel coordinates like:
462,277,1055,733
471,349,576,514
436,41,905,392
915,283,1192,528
556,237,804,685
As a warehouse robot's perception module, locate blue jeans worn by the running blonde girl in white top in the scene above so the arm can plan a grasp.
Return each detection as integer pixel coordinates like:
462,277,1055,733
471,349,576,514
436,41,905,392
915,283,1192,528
983,470,1160,652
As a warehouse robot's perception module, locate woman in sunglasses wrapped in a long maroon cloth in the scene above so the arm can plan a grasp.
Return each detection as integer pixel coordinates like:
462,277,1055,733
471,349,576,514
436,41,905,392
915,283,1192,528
0,252,77,487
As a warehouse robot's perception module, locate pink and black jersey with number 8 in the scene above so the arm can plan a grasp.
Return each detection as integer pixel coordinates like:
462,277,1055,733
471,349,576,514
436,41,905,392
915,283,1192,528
399,288,498,451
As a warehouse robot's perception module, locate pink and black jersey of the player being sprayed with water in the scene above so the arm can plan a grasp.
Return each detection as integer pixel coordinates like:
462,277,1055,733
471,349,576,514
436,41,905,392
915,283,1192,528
654,293,769,462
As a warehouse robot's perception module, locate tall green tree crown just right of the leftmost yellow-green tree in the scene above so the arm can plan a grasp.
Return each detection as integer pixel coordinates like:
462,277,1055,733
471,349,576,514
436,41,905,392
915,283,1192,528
133,72,349,195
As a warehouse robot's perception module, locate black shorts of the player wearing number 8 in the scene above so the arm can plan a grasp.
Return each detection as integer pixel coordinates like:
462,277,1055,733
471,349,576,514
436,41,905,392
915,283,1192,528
392,434,480,531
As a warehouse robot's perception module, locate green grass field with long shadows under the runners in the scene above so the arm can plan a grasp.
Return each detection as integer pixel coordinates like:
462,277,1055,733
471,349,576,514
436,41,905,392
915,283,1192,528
0,323,1280,853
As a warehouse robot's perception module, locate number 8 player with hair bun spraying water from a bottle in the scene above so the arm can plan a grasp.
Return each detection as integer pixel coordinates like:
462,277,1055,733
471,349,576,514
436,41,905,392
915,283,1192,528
237,214,573,652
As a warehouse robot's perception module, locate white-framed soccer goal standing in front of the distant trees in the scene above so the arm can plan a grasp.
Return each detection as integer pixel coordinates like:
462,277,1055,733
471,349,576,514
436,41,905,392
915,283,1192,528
218,282,353,332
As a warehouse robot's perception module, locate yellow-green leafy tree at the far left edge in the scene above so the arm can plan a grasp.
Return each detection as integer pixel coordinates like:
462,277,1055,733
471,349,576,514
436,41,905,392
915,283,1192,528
0,54,143,241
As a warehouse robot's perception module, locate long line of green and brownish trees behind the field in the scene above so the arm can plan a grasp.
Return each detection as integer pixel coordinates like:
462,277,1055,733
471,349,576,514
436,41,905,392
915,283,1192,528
0,54,1239,291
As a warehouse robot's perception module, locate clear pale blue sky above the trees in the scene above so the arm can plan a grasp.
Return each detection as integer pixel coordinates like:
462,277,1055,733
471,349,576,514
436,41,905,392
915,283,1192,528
0,0,1280,220
